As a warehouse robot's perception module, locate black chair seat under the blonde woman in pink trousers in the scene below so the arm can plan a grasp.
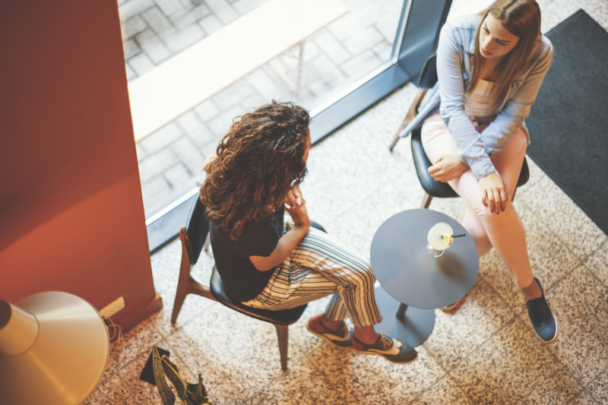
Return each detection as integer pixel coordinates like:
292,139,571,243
411,128,530,198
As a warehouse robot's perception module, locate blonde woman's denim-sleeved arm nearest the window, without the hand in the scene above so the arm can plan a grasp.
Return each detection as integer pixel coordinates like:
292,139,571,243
437,23,495,180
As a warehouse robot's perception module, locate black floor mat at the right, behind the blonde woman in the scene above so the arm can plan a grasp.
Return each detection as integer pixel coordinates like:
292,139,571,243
526,10,608,234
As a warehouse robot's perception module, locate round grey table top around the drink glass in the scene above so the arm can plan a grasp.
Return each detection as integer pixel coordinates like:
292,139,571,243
370,209,479,309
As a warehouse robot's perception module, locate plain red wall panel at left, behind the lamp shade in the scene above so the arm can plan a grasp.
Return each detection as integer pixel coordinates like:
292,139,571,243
0,0,158,319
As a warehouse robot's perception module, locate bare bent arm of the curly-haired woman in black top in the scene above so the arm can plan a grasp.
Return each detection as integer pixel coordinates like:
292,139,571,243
249,187,310,271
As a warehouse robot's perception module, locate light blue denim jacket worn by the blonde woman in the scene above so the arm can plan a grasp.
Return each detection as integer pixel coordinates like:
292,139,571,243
400,14,553,179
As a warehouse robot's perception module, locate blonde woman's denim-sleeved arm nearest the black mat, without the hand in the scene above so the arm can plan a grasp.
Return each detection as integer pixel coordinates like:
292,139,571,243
481,39,553,152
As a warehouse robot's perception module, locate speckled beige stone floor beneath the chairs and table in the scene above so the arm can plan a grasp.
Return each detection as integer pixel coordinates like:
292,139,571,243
86,0,608,405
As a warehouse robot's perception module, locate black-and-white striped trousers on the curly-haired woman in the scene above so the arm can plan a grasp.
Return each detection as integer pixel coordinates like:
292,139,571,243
243,228,382,328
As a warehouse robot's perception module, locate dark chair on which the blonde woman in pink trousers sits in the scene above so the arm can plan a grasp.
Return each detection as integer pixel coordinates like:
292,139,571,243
389,55,530,208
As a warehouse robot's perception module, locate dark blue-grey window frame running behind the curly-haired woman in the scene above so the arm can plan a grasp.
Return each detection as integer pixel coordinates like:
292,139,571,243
146,0,452,252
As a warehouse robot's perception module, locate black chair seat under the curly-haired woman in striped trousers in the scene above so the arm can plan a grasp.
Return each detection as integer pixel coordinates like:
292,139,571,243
209,267,306,325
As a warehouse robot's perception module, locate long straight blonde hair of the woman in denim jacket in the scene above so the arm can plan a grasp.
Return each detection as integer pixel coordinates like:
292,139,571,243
467,0,540,108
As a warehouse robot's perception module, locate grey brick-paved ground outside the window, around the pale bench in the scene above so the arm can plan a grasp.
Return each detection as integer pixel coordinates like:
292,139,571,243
118,0,403,216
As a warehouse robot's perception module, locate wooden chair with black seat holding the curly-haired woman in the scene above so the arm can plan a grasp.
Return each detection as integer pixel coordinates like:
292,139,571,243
171,198,325,370
